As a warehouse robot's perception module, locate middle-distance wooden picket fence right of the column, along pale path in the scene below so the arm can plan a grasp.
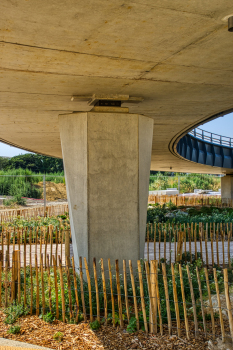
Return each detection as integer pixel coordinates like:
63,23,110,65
145,222,233,268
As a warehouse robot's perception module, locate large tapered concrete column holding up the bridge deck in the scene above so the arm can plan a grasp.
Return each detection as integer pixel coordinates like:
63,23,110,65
59,112,153,266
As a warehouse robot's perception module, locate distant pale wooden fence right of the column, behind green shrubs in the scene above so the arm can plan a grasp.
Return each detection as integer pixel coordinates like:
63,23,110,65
148,194,233,208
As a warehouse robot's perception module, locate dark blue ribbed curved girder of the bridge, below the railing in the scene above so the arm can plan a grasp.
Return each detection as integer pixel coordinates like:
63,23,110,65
176,134,233,169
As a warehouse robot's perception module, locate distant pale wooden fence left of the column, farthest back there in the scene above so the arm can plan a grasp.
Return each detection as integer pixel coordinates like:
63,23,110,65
0,203,69,222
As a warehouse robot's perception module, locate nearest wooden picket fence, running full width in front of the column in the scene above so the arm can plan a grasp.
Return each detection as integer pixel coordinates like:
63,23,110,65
0,250,233,342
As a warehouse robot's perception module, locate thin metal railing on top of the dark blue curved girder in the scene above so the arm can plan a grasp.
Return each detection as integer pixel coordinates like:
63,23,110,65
189,128,233,147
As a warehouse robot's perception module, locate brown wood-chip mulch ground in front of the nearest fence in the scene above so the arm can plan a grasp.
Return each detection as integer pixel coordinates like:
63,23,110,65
0,312,211,350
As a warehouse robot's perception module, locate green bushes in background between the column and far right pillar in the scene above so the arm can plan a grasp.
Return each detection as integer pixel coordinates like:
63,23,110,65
149,172,221,193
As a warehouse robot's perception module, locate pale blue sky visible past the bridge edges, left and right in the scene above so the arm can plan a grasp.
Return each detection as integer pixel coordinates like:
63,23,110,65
0,113,233,157
